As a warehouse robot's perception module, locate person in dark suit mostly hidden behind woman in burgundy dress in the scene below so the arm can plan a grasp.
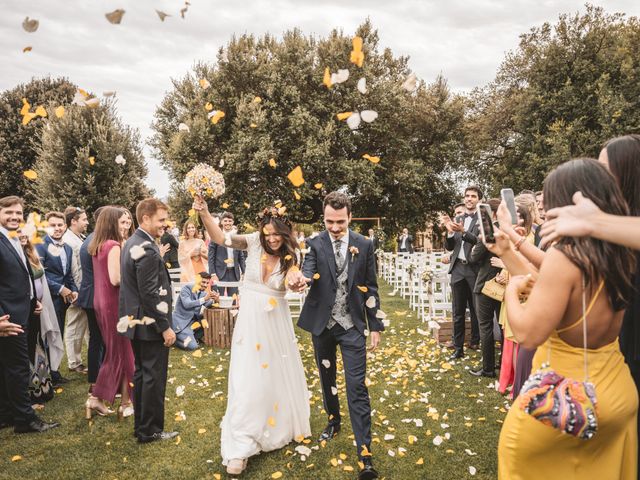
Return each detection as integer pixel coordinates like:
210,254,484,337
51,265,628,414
78,207,104,396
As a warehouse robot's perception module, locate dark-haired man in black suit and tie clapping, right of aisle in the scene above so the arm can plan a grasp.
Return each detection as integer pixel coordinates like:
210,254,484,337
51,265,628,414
444,185,482,359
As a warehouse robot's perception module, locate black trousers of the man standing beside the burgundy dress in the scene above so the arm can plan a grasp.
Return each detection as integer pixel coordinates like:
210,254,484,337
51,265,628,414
131,339,169,441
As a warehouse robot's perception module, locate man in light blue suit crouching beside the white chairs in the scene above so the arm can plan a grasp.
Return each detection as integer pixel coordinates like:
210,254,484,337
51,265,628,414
172,272,220,350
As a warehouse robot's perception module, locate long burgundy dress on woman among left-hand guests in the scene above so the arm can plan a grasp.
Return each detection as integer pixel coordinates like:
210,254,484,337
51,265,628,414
92,240,135,403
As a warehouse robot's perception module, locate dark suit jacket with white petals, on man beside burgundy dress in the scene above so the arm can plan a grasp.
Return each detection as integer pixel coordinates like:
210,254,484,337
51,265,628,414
119,229,172,341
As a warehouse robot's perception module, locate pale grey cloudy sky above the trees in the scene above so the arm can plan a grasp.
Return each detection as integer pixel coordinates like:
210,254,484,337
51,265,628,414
0,0,640,196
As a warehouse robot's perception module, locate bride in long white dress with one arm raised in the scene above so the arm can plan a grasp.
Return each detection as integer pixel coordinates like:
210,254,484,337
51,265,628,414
193,198,311,475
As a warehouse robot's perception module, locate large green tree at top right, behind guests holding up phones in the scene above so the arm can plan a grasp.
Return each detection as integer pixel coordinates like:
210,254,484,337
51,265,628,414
467,5,640,193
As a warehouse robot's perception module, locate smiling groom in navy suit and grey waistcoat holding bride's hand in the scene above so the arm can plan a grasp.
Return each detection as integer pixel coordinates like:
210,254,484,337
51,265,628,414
289,192,384,480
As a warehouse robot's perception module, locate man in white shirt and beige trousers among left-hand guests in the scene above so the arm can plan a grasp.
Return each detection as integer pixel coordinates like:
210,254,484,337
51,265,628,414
62,207,89,374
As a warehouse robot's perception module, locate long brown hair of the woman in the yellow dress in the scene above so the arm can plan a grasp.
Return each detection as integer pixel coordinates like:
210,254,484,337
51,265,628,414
544,158,635,310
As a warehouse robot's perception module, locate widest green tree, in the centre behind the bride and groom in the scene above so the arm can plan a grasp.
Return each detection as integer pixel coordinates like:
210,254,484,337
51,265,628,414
150,22,464,233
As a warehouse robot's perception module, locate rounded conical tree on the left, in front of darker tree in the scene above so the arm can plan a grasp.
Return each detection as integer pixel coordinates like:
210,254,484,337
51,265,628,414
33,101,150,213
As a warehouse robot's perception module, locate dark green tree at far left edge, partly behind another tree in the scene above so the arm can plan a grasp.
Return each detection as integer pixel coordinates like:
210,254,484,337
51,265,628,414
0,77,77,203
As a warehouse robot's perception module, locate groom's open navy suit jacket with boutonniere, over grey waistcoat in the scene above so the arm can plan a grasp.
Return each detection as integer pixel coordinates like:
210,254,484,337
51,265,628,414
298,230,384,336
